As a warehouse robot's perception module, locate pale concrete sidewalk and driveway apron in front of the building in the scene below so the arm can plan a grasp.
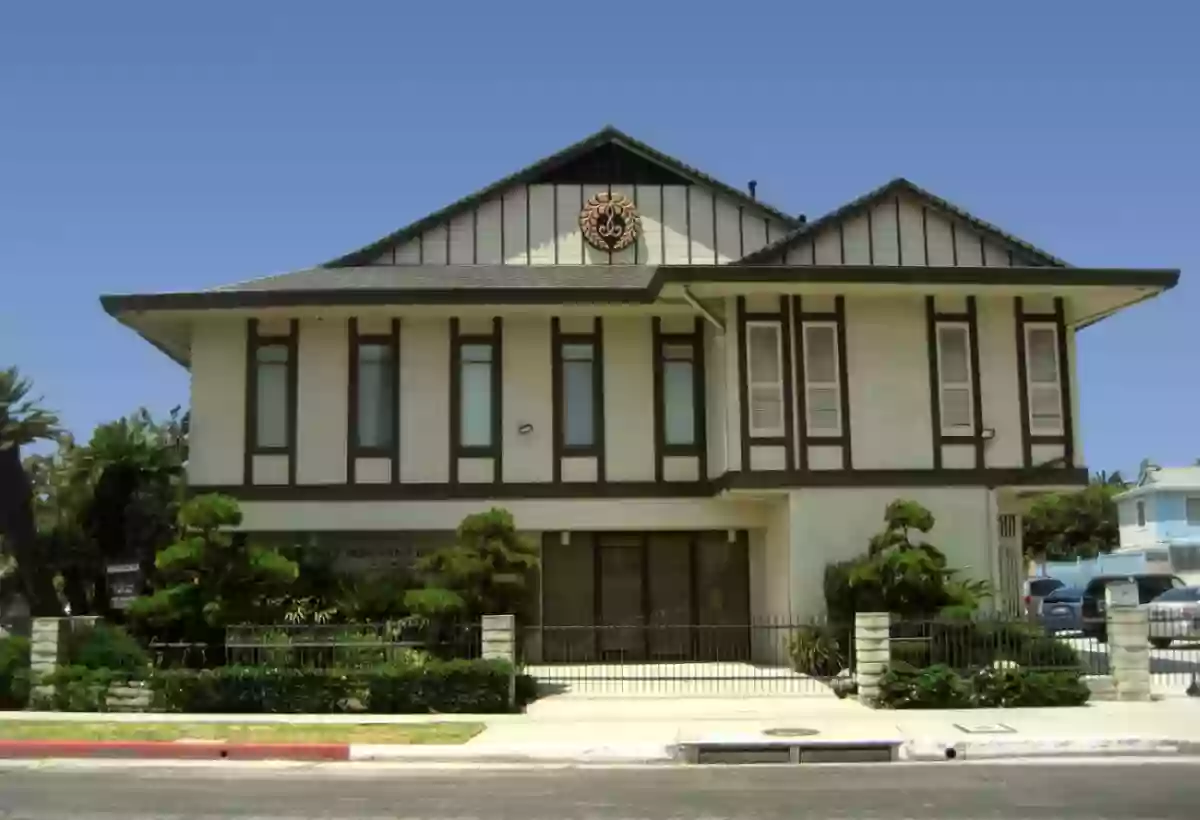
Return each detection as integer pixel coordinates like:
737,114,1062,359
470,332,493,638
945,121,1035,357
0,695,1200,764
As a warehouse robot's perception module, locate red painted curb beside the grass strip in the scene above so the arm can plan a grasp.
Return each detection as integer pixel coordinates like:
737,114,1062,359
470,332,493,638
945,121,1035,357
0,740,350,760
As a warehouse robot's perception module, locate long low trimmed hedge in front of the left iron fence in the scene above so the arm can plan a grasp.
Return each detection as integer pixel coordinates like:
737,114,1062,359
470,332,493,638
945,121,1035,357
149,660,536,714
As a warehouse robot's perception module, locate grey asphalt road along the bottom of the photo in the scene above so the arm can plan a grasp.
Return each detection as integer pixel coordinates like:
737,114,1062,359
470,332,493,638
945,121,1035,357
0,761,1200,820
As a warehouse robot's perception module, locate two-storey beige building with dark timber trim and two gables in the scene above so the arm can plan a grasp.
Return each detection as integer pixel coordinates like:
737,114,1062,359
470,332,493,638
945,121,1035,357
102,128,1177,654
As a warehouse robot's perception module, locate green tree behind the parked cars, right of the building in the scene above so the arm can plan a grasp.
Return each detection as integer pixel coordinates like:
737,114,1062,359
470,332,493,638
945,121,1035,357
1024,475,1124,561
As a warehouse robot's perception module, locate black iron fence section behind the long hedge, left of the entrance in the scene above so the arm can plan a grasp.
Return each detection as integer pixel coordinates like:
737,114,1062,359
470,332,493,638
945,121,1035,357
150,622,481,669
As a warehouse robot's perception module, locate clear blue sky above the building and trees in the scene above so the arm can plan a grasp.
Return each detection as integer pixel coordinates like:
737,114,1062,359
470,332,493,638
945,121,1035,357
0,0,1200,471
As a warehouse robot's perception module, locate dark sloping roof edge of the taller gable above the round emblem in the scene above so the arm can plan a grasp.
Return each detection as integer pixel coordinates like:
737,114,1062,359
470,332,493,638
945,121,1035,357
322,125,799,268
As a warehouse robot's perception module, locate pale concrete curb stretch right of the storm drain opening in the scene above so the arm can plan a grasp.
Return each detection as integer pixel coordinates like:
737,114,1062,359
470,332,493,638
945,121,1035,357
899,737,1200,762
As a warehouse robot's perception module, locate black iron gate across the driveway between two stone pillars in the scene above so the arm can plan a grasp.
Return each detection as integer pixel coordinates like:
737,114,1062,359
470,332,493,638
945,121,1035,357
518,621,853,694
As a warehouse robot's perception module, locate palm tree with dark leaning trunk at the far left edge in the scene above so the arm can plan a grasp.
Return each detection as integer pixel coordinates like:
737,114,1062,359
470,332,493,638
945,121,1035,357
0,367,62,615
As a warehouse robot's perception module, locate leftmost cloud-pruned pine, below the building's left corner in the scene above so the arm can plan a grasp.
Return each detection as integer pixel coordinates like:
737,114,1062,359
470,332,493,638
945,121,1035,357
130,495,299,640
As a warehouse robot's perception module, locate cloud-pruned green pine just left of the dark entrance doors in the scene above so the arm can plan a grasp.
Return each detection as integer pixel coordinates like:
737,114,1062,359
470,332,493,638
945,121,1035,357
404,508,538,620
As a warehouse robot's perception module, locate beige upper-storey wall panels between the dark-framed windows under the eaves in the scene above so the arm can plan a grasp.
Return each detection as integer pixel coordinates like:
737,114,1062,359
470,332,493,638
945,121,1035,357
190,293,1082,497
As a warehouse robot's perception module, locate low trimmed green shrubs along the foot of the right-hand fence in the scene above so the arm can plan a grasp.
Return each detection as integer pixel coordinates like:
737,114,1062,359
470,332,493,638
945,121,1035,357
877,663,1091,710
